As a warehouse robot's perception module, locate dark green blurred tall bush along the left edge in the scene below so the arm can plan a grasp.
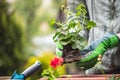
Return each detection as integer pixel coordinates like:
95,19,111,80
0,0,25,76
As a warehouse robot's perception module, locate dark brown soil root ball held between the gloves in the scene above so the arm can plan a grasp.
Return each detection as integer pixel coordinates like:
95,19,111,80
62,45,81,63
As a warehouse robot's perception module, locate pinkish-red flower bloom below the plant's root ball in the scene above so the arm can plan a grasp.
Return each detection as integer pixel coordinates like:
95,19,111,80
50,57,63,69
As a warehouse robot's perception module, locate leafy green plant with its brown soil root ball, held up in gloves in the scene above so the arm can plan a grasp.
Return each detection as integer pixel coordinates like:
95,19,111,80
52,3,96,63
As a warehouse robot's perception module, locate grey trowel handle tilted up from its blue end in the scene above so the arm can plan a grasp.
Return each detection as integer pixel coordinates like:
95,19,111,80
21,61,41,78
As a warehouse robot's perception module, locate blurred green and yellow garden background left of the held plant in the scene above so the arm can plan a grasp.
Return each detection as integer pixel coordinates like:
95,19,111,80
0,0,81,80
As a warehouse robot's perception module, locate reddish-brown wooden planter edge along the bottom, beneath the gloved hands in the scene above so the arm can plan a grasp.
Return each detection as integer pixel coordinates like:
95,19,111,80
38,74,120,80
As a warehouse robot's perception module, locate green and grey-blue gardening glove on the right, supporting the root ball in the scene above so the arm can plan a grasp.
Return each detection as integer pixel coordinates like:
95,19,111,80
77,32,120,68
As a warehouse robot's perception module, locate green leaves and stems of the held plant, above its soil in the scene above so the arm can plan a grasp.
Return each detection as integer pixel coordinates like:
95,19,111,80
51,3,96,49
